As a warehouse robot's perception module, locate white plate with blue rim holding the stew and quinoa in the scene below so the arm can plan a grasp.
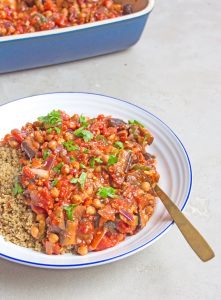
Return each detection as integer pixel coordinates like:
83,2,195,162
0,93,192,269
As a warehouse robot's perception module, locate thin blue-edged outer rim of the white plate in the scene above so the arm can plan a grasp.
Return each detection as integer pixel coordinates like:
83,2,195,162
0,92,192,269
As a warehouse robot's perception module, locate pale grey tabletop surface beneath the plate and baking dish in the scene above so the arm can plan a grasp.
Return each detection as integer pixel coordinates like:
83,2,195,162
0,0,221,300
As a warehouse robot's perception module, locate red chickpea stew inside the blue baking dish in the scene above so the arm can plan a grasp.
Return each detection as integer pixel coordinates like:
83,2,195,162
0,0,133,36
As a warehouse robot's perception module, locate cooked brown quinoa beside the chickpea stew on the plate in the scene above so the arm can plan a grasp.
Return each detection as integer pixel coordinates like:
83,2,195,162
0,146,41,251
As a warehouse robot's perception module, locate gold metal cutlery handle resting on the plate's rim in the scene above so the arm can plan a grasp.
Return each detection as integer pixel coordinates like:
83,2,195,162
154,185,215,262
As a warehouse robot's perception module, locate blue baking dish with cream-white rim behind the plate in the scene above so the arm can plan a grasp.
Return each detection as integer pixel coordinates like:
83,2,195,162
0,0,154,74
